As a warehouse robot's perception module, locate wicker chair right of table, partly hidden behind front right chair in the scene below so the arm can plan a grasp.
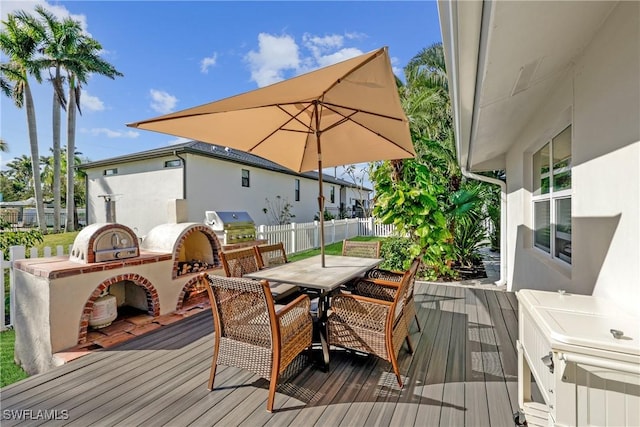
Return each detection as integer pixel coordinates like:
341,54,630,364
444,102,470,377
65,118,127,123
354,257,422,331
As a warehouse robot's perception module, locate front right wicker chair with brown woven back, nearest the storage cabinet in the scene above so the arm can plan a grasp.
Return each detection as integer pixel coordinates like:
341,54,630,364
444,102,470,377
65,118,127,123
327,262,413,387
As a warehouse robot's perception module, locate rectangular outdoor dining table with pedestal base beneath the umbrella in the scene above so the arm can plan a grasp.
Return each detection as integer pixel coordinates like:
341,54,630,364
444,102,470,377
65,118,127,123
243,255,382,370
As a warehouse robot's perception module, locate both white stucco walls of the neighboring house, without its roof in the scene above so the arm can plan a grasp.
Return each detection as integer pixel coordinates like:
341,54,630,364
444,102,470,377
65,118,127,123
87,154,352,237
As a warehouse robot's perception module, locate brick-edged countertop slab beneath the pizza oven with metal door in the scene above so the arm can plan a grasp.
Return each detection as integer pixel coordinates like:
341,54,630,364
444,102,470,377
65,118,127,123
13,250,172,279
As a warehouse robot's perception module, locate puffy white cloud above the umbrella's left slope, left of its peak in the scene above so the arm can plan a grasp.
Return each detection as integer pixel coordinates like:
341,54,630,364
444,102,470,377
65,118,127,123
245,33,300,87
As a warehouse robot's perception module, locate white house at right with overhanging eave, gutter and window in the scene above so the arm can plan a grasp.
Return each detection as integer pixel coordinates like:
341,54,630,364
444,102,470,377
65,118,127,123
438,1,640,312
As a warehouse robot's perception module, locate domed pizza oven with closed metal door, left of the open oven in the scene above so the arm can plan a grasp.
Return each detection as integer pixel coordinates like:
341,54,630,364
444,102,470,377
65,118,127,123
69,223,140,264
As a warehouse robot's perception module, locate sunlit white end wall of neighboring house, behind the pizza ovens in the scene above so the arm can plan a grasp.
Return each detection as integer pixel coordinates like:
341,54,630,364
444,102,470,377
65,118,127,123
87,156,183,236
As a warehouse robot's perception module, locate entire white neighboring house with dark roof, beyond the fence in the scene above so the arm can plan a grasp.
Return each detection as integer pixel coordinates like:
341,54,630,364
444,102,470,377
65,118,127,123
79,141,370,236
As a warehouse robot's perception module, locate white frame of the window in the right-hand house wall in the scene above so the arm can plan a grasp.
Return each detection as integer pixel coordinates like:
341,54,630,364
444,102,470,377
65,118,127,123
531,123,573,266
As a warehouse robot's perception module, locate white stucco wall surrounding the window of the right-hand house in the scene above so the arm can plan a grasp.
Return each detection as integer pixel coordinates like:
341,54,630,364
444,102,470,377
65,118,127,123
507,2,640,316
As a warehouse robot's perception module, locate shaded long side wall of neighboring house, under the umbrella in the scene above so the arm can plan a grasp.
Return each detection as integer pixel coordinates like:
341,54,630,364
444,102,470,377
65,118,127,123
187,155,340,224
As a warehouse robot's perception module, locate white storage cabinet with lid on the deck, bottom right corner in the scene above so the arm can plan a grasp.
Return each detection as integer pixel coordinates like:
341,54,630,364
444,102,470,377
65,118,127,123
514,289,640,426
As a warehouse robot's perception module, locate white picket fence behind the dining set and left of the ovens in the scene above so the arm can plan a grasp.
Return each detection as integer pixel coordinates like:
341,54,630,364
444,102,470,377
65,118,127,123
0,218,394,331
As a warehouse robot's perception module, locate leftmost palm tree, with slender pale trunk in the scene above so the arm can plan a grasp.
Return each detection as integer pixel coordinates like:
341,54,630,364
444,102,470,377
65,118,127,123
0,12,47,233
